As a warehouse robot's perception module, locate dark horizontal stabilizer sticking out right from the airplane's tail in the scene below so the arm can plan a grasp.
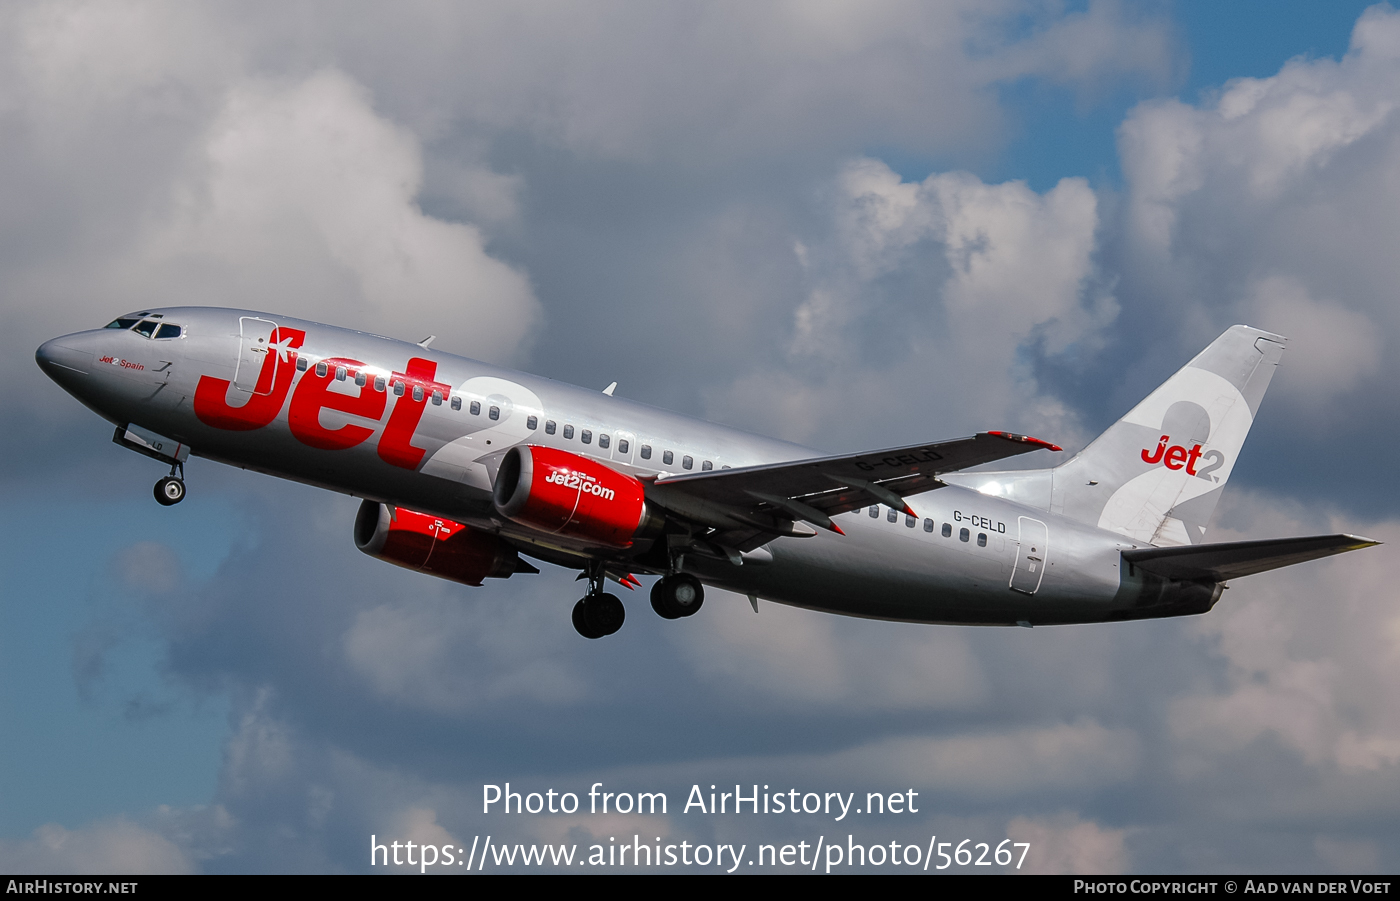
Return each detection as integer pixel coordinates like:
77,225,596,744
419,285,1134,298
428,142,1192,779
1123,534,1380,582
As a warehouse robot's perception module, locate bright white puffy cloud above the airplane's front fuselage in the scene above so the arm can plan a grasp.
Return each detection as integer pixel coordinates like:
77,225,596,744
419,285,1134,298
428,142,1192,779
130,70,539,360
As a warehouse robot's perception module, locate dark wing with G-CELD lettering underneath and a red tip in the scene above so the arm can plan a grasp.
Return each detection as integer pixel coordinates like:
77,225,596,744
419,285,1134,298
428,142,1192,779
647,432,1060,550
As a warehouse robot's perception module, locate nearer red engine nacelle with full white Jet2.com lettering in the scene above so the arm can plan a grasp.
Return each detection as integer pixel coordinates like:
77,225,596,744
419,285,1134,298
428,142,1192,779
496,445,657,547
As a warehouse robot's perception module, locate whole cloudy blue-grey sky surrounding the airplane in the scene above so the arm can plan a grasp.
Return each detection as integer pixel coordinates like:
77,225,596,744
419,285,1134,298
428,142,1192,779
0,0,1400,874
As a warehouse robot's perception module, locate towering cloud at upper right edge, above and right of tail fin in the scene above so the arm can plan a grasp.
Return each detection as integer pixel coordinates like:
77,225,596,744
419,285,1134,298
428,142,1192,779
1120,6,1400,425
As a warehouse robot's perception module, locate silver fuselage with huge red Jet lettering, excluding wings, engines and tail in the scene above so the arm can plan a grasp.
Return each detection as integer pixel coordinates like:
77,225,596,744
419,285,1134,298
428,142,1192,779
38,308,1219,625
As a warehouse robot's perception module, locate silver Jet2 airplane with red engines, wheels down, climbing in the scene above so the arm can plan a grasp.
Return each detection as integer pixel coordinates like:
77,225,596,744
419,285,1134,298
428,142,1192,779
35,313,1378,638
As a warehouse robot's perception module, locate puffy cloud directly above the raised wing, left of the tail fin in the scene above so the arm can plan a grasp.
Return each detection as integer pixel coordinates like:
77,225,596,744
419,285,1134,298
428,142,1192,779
710,158,1117,446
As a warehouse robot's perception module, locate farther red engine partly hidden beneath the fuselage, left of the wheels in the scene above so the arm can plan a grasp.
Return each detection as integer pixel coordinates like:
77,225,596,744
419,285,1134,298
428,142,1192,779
354,501,529,585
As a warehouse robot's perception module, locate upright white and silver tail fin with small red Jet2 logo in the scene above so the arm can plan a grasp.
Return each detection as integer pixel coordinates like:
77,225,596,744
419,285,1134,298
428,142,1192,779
1050,326,1287,546
